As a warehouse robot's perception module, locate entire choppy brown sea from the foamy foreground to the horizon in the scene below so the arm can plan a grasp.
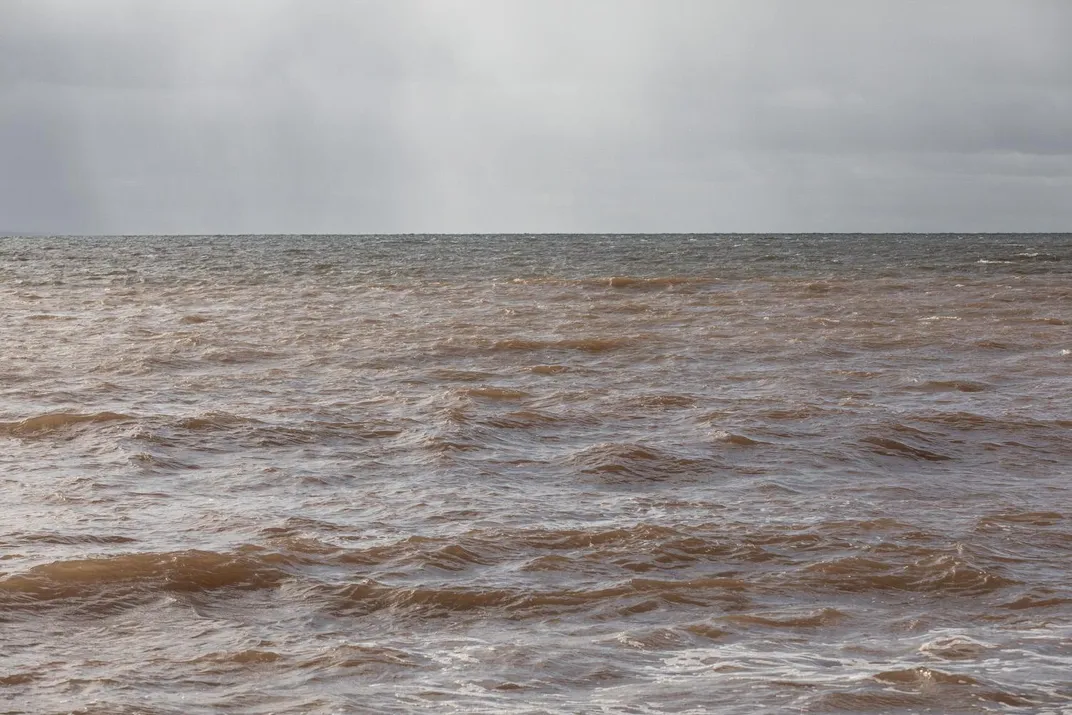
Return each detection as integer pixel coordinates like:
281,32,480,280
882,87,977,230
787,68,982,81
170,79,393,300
0,235,1072,715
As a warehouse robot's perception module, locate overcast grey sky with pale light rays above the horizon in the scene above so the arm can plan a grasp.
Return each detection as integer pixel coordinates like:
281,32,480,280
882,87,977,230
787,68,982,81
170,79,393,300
0,0,1072,234
